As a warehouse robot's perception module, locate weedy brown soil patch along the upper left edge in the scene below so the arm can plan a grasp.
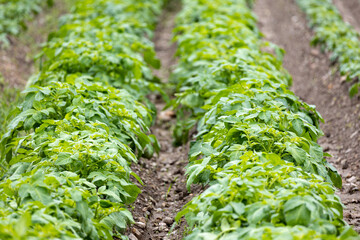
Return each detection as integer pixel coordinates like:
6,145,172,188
0,0,67,88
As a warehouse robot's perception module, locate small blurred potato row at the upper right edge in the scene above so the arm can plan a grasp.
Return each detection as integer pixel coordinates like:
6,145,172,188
297,0,360,97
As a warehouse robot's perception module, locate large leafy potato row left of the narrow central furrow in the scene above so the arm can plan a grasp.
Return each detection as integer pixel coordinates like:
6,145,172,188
0,0,162,240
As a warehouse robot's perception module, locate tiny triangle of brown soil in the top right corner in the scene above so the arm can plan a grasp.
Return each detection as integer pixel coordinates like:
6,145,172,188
333,0,360,32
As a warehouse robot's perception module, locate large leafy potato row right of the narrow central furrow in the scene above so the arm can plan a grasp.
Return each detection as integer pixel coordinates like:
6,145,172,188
172,0,359,240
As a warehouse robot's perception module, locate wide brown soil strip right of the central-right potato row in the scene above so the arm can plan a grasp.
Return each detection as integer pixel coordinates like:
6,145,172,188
255,0,360,232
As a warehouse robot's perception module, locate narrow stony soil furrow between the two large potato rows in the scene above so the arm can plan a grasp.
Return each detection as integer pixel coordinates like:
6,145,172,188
127,1,201,240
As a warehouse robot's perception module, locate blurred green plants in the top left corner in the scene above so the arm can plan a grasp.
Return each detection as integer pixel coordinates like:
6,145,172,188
0,0,53,46
